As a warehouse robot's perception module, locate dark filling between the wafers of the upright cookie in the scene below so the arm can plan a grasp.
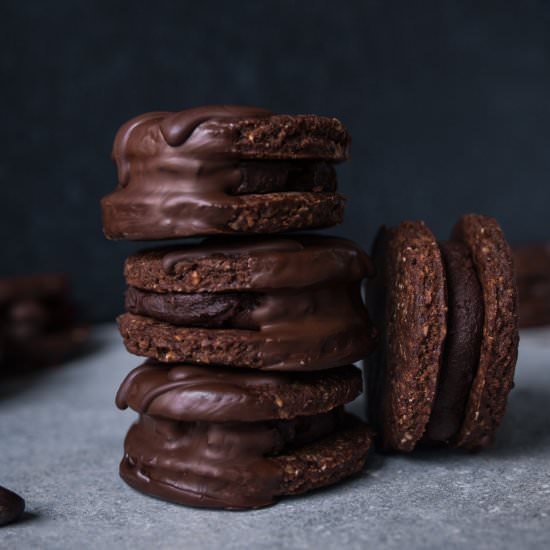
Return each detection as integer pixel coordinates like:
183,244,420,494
425,241,484,442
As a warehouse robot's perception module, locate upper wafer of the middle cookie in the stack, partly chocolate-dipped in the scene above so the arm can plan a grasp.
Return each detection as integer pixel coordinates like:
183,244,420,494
124,235,372,293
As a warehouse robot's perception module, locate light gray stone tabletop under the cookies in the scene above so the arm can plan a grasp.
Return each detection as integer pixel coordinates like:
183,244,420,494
0,326,550,550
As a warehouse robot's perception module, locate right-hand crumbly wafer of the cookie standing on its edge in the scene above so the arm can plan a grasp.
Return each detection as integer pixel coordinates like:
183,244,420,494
453,214,519,450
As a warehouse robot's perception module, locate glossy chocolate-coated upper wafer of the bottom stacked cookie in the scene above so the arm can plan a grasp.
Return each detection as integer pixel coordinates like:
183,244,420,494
116,362,362,422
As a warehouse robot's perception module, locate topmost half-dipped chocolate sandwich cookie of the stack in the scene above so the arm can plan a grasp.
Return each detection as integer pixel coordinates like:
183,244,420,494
102,105,350,240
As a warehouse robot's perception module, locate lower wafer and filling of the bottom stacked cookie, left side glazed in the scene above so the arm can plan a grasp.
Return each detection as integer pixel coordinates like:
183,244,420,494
120,416,371,509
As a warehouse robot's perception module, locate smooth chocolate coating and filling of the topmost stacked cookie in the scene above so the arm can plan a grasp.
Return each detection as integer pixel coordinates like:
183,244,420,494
102,106,348,239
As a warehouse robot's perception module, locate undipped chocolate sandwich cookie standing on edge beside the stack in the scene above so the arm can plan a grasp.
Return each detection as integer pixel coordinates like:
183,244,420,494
367,214,518,451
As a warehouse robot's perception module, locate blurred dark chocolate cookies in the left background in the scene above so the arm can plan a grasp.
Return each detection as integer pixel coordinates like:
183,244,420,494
0,274,88,375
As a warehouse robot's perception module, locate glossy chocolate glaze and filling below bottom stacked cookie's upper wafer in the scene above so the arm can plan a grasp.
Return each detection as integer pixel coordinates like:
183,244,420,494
120,409,342,509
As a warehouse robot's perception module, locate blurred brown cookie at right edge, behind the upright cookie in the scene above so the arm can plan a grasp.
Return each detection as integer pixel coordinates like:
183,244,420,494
514,242,550,328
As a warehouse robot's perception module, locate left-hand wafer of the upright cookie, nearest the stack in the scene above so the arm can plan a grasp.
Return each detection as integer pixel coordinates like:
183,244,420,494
368,222,447,451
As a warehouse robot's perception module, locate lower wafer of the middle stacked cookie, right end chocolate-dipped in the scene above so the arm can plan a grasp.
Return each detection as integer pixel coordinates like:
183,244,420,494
118,313,375,371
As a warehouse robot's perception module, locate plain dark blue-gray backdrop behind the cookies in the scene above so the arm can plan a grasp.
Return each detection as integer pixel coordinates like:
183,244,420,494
0,0,550,320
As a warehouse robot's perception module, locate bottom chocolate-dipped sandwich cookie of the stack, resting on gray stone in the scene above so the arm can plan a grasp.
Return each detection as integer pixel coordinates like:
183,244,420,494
117,362,371,509
